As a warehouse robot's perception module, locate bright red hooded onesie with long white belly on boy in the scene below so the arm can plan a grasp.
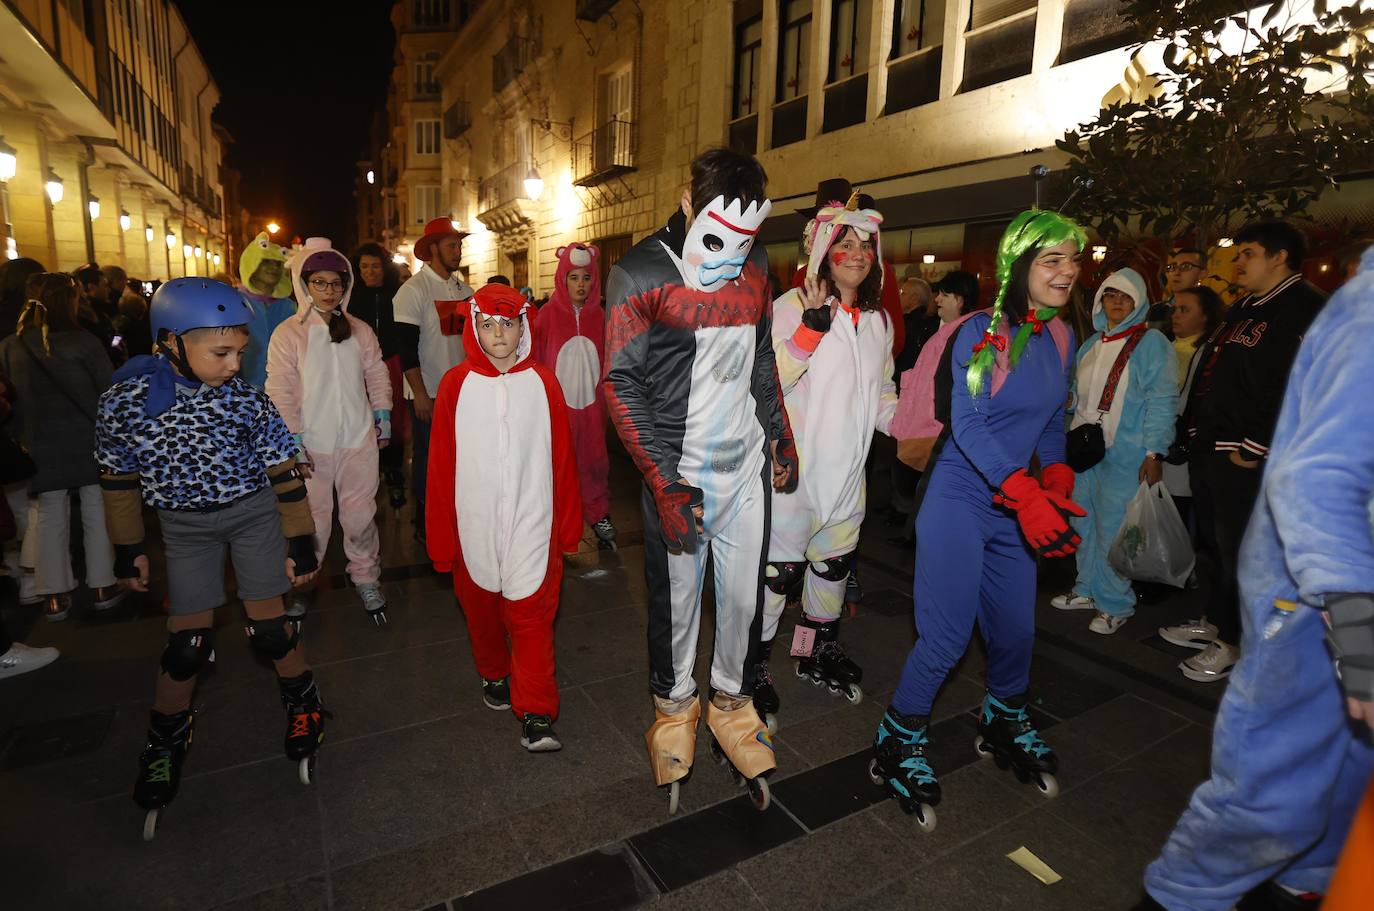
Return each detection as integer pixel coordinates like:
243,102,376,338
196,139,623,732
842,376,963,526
425,284,583,719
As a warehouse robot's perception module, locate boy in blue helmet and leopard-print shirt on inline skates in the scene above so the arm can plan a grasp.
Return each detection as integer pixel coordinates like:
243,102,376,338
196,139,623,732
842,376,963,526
96,278,324,838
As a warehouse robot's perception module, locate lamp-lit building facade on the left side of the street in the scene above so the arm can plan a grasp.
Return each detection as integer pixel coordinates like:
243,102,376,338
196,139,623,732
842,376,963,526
0,0,232,279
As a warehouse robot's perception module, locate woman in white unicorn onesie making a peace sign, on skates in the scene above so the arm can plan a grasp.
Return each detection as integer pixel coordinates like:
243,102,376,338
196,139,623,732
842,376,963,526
754,192,897,736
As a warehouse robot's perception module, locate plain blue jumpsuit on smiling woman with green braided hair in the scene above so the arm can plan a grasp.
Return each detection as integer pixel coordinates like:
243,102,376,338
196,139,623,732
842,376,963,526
892,313,1069,715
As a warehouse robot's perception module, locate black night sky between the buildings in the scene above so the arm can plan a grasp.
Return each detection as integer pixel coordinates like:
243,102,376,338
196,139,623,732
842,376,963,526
177,0,396,243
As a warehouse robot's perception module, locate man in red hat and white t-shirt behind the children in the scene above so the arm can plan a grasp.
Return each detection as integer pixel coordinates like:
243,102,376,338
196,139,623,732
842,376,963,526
392,218,473,539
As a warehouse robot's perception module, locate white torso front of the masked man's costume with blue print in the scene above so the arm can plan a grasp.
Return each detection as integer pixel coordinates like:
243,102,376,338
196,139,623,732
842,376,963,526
677,326,764,537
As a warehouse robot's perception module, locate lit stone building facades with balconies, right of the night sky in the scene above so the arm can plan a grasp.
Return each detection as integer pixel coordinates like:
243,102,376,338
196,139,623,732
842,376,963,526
359,0,1369,295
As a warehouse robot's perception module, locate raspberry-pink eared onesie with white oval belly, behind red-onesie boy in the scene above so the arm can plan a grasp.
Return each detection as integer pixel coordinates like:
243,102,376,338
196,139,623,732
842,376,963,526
534,243,610,525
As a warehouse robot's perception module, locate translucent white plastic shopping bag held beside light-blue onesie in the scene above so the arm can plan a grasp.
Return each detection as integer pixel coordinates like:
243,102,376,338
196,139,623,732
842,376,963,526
1107,481,1197,588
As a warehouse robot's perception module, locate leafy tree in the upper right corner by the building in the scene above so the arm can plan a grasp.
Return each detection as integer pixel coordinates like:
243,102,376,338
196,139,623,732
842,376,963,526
1055,0,1374,258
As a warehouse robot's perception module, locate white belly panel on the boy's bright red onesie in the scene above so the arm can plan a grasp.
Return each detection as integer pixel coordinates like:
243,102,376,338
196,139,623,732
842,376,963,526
453,370,554,600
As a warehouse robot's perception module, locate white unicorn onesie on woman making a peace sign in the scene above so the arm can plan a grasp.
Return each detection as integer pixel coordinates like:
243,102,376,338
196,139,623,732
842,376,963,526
763,201,897,642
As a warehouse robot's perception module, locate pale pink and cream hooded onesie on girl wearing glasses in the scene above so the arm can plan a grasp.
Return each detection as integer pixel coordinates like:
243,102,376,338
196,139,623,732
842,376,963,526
267,238,392,585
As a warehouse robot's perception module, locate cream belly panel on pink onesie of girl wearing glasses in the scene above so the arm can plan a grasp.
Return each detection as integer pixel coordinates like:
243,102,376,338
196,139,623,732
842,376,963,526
301,325,374,453
